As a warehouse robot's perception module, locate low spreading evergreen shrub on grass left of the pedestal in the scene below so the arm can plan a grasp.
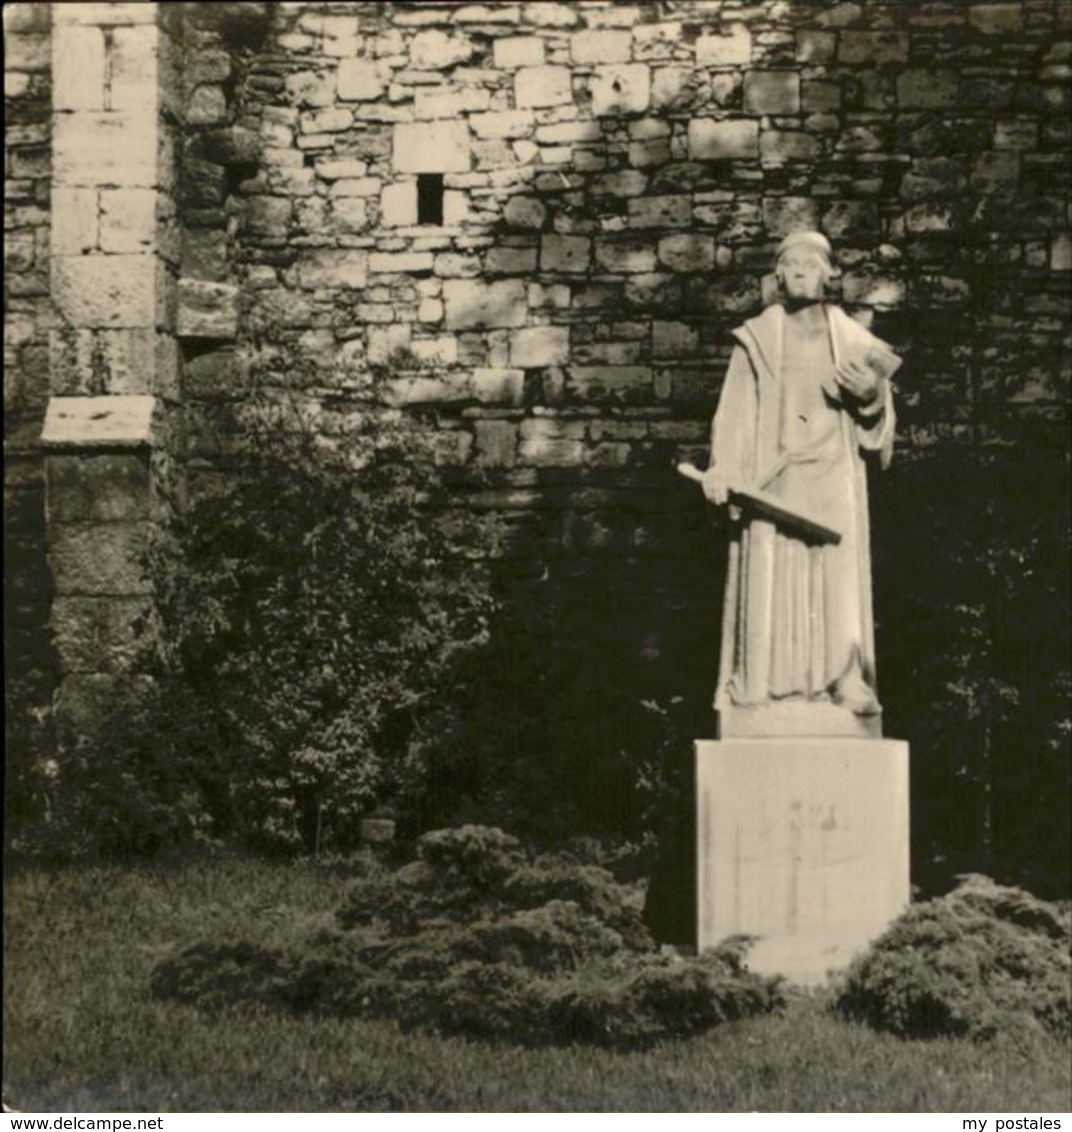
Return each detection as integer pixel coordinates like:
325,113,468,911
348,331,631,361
153,826,784,1049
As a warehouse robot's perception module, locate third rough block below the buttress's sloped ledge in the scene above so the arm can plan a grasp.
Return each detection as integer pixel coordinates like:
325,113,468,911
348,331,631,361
50,597,157,675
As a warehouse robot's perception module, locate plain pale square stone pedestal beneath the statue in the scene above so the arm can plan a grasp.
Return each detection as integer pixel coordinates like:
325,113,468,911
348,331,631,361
696,738,909,985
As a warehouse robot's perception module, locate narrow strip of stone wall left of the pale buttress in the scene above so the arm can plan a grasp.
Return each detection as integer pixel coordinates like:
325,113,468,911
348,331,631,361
3,3,52,703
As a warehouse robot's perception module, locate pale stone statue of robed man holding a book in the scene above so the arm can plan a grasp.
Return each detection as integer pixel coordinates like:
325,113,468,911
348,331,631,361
702,232,900,737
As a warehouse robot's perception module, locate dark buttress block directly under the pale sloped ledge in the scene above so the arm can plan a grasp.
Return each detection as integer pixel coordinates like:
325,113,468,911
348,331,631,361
45,448,154,523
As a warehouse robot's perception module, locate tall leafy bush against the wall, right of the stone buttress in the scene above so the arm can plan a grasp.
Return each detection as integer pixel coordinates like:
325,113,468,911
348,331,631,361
155,402,494,851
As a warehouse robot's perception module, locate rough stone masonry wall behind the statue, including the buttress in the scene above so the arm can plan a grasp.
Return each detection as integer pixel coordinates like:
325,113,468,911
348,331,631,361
5,0,1072,796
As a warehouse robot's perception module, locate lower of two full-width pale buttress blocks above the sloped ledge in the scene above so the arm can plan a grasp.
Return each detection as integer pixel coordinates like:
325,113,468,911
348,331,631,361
52,255,157,327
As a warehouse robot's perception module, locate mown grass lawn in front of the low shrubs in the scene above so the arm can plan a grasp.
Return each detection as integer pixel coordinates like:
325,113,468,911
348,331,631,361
5,858,1072,1113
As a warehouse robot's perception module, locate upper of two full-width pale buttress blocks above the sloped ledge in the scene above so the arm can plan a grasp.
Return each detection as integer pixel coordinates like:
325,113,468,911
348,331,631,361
52,105,159,188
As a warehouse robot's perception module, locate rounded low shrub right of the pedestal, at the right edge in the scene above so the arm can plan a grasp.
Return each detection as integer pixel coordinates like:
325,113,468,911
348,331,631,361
837,876,1072,1040
